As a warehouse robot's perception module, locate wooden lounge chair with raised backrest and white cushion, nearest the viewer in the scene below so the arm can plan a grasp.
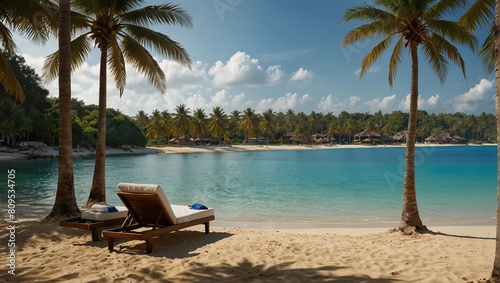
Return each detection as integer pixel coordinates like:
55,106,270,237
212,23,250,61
102,183,215,253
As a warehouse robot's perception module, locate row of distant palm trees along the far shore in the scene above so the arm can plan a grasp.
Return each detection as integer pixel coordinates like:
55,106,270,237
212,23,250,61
134,107,496,144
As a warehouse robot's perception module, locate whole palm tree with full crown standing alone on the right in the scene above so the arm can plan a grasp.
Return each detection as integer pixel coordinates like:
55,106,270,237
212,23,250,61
343,0,475,230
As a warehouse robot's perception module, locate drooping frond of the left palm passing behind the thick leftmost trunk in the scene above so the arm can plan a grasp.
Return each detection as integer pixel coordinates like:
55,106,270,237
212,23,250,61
42,34,92,82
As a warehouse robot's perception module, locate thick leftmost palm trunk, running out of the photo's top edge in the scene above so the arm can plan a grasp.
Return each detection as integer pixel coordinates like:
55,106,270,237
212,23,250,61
44,0,80,221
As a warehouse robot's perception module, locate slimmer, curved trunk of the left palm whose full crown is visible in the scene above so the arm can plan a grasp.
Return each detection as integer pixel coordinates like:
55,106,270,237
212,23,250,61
83,46,108,208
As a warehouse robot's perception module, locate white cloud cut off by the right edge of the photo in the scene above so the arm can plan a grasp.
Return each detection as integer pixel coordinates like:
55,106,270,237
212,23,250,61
453,79,495,112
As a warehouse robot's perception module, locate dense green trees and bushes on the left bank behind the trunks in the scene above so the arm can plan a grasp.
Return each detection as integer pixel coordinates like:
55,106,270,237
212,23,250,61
0,54,147,150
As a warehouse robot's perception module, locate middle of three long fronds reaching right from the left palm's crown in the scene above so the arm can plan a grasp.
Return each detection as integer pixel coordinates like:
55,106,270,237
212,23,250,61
125,25,192,69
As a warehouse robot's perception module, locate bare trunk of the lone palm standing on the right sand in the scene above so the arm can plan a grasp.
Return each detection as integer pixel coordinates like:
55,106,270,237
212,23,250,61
399,42,426,231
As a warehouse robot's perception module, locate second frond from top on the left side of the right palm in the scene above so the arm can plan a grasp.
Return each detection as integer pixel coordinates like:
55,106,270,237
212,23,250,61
342,20,397,48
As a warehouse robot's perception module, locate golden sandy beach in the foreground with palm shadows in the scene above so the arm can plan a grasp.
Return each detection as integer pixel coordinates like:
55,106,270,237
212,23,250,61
0,208,495,282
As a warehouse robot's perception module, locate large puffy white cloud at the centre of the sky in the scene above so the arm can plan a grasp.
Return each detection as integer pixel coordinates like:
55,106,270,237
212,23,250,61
208,51,283,87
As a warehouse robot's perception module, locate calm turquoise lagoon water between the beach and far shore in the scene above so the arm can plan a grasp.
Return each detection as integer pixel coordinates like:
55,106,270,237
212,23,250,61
0,146,497,223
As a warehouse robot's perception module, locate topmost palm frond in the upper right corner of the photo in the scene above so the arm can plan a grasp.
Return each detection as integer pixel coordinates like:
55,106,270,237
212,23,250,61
458,0,495,32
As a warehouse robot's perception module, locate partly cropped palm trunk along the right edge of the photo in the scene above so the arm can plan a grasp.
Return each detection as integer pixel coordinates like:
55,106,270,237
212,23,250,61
490,0,500,282
